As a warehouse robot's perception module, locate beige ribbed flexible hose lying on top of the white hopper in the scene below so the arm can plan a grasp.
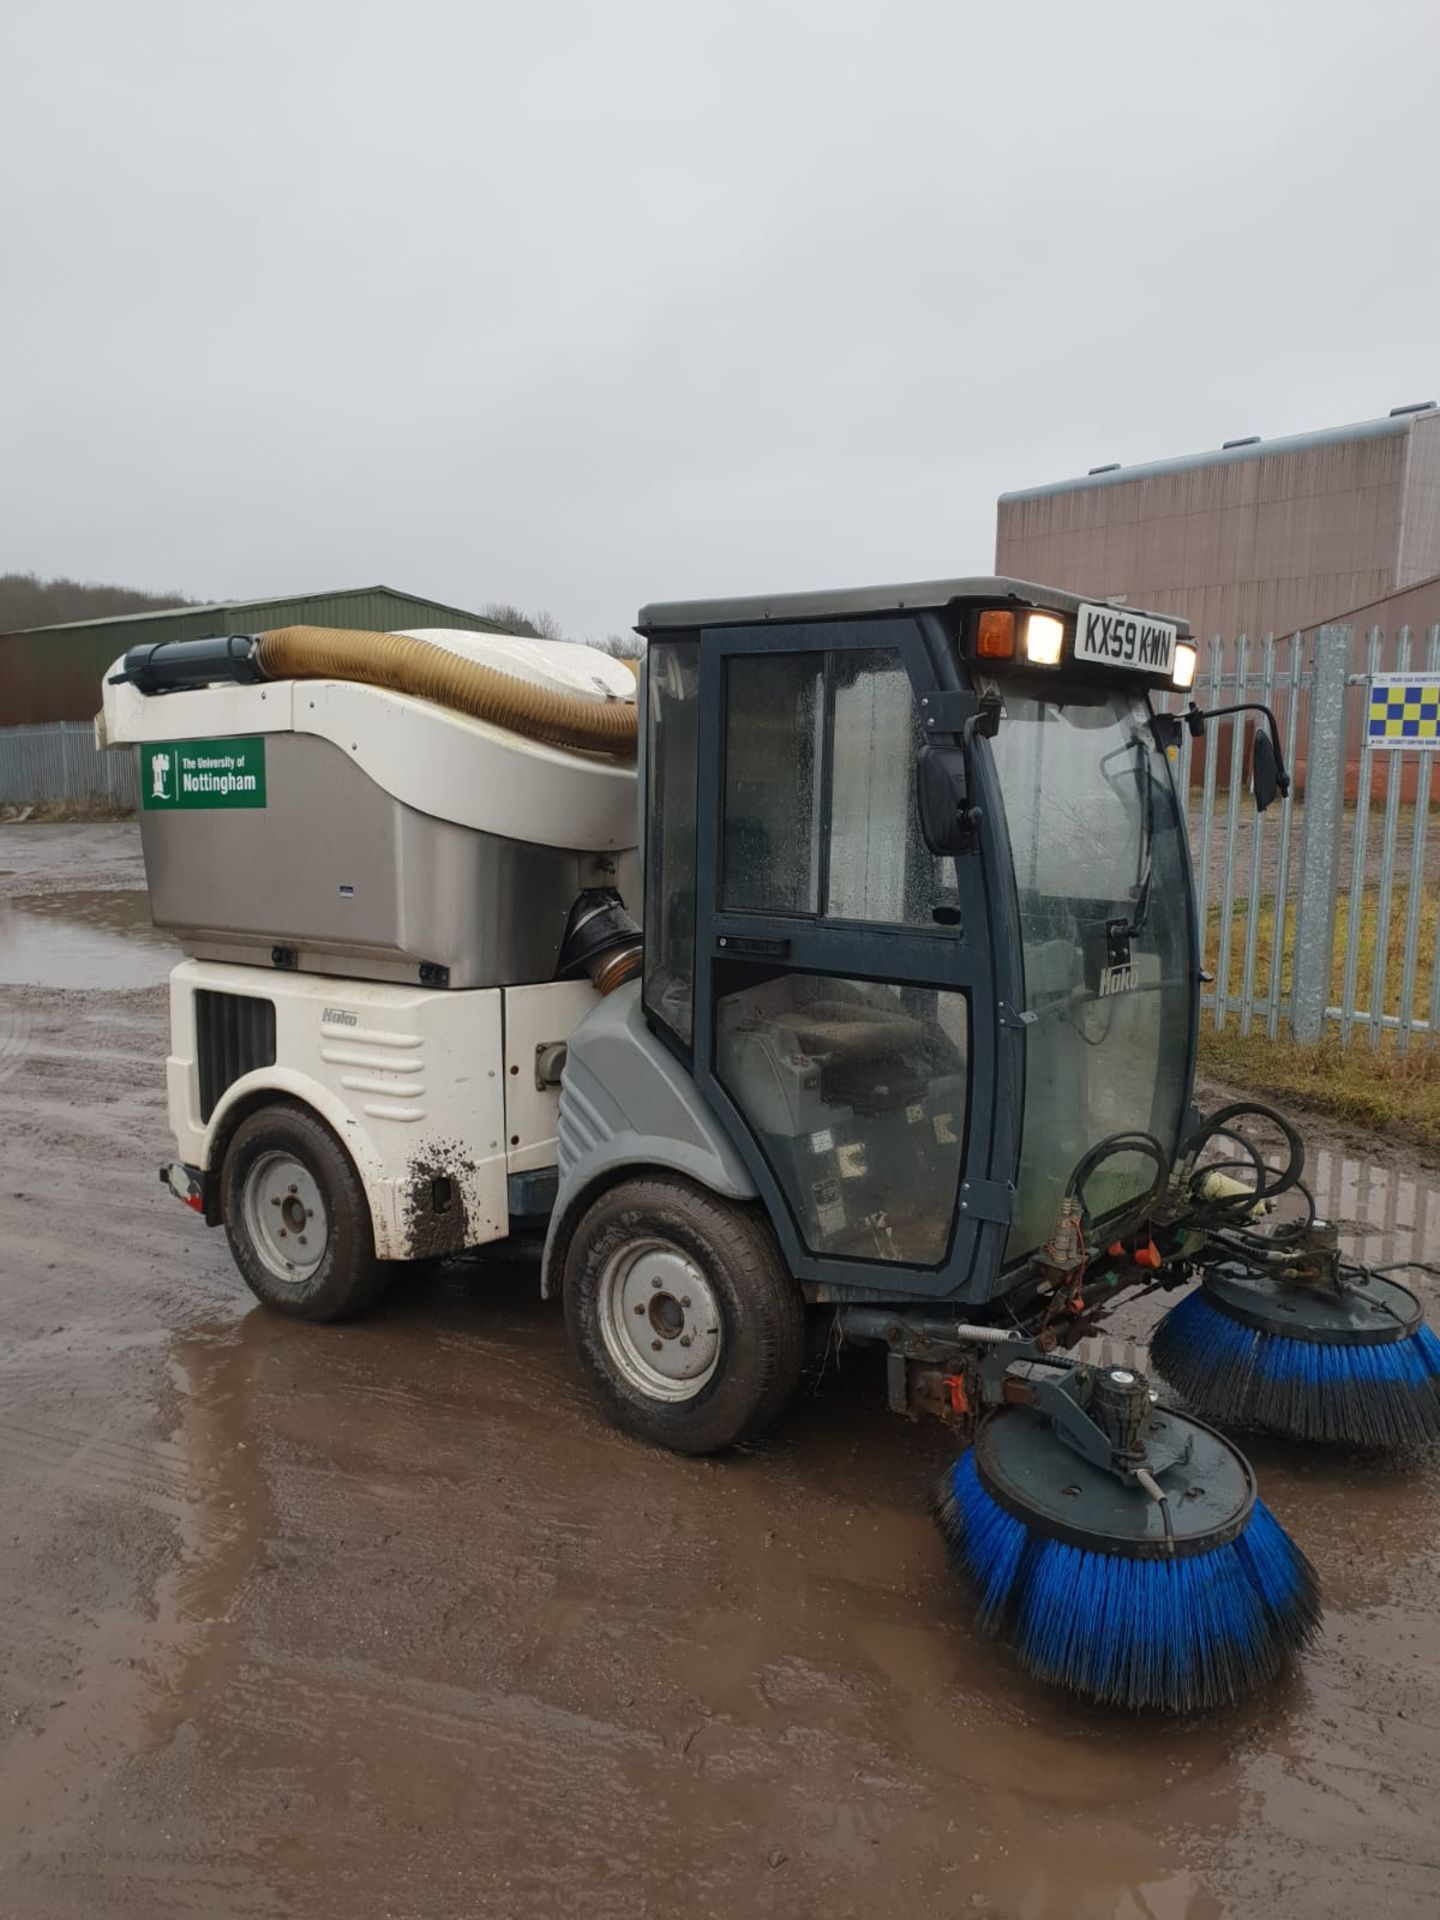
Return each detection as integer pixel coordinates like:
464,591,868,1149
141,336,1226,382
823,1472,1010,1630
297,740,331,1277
259,626,636,758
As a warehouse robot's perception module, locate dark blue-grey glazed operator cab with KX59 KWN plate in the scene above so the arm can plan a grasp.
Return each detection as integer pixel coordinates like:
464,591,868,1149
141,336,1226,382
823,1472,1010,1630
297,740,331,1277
637,578,1200,1302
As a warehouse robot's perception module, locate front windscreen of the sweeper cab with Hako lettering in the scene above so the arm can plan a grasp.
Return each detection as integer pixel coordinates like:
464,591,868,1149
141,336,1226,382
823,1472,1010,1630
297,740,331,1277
991,685,1196,1263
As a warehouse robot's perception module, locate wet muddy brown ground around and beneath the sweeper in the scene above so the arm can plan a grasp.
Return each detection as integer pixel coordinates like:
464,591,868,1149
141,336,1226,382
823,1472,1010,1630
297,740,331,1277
0,826,1440,1920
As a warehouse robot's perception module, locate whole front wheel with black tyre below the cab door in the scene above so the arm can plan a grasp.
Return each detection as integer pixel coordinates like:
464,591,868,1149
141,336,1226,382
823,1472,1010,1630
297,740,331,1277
564,1175,804,1453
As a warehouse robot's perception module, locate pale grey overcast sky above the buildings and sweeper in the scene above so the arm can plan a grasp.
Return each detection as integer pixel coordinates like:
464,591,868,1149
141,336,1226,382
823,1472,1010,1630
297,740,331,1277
0,0,1440,634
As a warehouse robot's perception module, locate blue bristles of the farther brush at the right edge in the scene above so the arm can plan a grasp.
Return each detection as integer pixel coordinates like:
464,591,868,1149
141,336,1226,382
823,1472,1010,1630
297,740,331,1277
1150,1286,1440,1448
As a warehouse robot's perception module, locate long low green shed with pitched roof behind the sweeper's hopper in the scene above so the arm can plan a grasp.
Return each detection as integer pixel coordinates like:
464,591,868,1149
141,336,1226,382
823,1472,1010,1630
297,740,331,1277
0,588,507,726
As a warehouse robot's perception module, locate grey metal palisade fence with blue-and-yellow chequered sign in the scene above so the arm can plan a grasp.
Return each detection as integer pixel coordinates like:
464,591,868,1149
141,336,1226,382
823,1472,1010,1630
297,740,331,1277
1169,626,1440,1050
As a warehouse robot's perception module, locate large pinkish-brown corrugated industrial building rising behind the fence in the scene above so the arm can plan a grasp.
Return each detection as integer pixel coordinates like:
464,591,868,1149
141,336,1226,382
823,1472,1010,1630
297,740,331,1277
995,401,1440,637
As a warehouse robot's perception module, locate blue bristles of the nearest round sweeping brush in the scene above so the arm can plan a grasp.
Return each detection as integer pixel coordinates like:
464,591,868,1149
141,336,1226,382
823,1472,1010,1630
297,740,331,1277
939,1450,1319,1713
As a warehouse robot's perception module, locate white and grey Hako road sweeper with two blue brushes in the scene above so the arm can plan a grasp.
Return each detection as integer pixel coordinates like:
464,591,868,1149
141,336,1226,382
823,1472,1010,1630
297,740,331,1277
102,578,1440,1709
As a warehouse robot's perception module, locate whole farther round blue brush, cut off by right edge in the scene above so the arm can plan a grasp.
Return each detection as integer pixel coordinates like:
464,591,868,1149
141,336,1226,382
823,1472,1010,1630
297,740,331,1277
1150,1265,1440,1448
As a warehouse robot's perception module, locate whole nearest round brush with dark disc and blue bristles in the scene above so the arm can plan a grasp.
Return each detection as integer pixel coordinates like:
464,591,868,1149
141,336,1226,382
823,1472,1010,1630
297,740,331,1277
939,1407,1319,1713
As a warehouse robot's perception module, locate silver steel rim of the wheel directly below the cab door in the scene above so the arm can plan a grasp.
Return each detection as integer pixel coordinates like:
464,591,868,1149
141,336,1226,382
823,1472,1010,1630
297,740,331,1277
599,1238,724,1405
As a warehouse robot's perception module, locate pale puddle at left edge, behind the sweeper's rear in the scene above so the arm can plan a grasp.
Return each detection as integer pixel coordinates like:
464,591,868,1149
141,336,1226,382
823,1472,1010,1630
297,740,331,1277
0,889,180,991
